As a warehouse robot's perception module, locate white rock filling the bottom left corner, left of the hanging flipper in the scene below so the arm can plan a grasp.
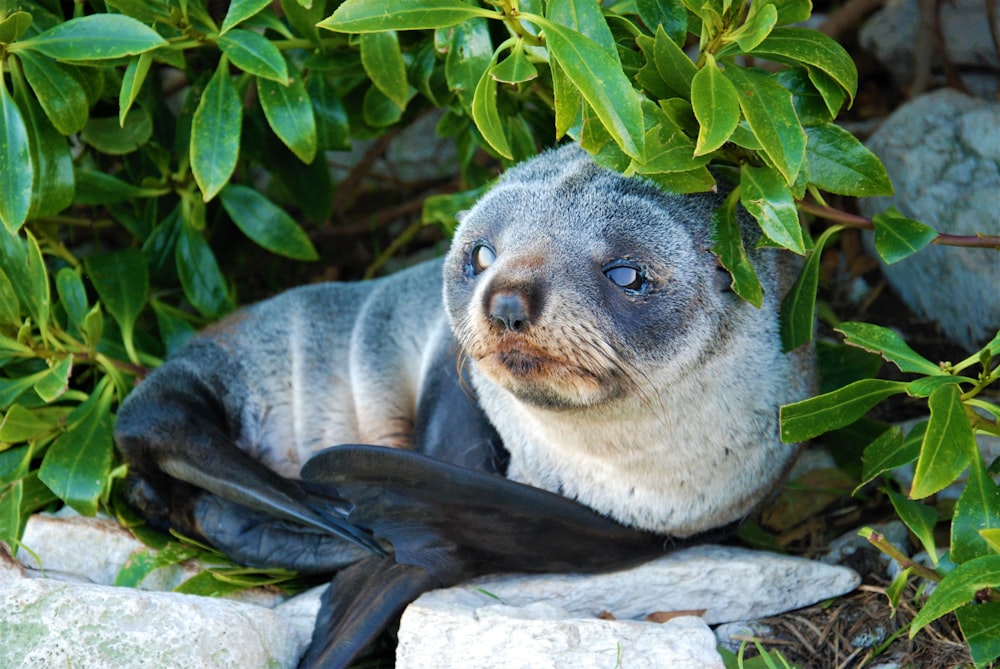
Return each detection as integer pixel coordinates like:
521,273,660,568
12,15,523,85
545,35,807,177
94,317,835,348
0,578,302,669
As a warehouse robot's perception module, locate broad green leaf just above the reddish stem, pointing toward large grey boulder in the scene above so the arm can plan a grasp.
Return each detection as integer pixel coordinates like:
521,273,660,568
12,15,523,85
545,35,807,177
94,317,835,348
806,123,892,197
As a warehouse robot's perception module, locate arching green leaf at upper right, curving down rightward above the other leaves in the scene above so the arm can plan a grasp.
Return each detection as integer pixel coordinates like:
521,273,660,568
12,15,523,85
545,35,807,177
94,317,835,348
752,27,858,104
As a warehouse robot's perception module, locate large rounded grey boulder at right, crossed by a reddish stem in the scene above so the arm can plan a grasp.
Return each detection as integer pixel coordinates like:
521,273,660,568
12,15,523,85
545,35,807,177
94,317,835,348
859,89,1000,352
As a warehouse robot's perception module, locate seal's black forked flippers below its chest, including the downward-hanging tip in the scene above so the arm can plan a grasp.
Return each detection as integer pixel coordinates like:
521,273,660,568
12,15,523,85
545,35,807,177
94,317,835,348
300,446,664,669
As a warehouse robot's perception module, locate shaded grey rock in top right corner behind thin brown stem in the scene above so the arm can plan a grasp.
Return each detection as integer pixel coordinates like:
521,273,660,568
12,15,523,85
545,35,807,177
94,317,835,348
858,0,1000,96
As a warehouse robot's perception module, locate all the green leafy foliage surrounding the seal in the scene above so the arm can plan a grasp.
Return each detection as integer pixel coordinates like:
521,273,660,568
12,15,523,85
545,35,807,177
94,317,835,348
0,0,1000,661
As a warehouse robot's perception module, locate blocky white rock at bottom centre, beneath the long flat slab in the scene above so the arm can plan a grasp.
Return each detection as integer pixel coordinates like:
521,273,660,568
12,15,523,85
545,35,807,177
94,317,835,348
396,588,723,669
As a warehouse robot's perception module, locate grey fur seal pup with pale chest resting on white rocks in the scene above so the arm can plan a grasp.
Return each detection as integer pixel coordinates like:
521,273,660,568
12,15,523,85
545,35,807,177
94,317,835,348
115,146,813,667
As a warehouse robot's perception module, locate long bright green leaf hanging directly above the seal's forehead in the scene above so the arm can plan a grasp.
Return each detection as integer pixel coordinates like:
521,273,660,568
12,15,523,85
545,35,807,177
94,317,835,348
526,16,645,160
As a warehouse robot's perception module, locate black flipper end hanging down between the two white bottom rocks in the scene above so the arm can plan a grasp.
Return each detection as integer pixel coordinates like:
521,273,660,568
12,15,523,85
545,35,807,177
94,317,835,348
299,557,441,669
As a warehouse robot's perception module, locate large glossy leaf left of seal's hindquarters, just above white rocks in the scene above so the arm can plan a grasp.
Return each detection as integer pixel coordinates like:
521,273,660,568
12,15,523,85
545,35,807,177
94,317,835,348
38,384,114,516
